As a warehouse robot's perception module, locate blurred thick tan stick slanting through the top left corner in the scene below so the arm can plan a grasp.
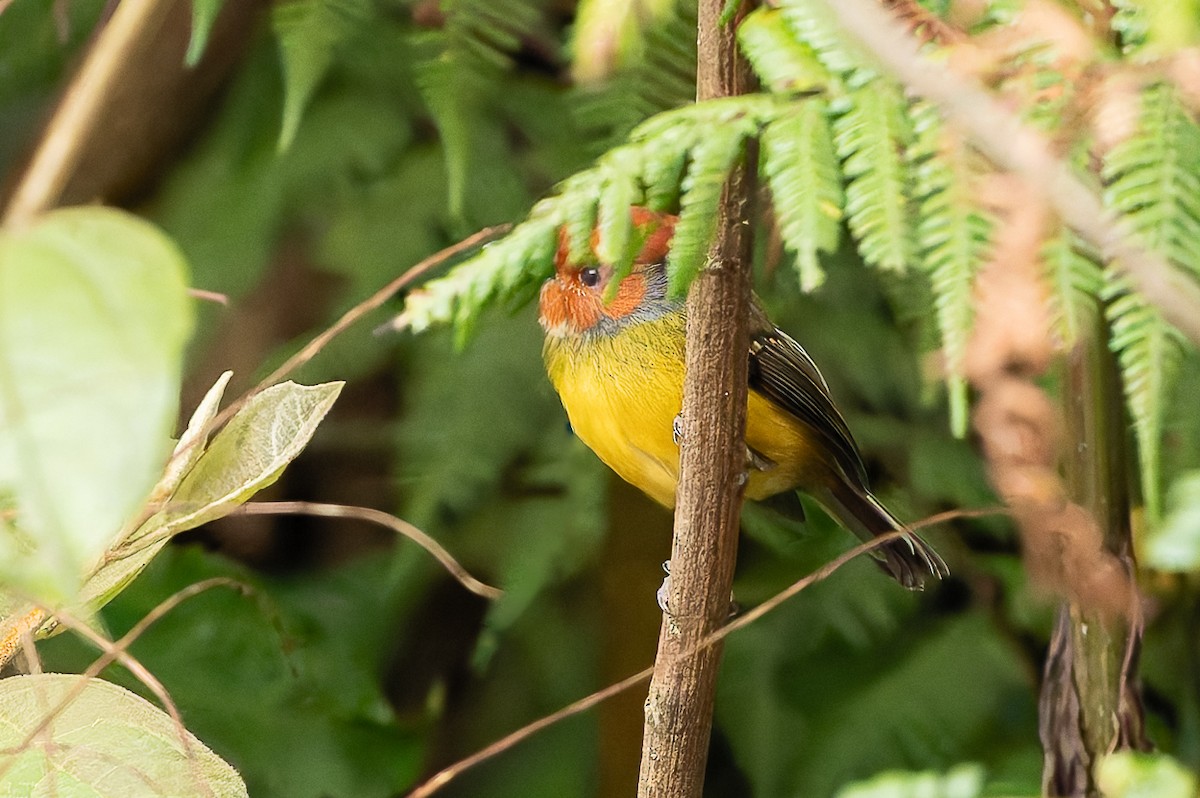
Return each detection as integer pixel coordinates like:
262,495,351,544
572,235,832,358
4,0,175,226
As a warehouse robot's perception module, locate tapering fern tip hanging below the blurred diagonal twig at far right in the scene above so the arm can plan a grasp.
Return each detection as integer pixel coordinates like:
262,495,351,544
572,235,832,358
1108,289,1183,527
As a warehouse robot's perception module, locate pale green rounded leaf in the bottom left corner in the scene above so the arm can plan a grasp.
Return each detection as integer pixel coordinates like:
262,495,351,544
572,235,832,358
0,673,247,798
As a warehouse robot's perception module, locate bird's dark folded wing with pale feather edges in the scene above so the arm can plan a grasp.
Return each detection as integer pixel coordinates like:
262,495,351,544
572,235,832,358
750,323,866,487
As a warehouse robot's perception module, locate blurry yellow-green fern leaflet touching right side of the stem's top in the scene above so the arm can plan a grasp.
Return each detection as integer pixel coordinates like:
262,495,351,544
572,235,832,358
738,8,832,92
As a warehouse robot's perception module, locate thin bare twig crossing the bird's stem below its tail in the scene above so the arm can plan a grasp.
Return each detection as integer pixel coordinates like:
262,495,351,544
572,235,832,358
408,508,1008,798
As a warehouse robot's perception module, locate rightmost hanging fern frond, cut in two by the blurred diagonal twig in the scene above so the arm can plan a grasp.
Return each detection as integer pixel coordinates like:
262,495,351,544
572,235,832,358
1102,83,1200,523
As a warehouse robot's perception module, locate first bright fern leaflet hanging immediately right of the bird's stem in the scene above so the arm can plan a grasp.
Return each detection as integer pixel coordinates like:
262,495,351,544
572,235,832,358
762,97,845,292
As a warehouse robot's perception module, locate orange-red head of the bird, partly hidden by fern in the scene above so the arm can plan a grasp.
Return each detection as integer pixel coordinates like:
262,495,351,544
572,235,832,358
539,208,679,337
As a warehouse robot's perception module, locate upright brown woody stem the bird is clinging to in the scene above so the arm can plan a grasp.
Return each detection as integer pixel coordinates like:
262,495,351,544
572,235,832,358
637,0,755,798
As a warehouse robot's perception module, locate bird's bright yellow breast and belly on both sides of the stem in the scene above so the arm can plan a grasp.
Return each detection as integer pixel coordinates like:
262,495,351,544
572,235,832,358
545,313,814,508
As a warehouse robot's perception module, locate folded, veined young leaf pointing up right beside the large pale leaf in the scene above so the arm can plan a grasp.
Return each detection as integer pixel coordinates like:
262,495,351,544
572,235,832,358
73,378,342,610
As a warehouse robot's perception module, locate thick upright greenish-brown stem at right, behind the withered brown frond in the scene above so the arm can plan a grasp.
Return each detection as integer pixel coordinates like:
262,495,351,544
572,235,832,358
1038,313,1146,797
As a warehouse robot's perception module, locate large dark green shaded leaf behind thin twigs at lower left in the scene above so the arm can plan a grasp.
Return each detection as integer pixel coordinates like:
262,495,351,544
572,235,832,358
38,545,429,798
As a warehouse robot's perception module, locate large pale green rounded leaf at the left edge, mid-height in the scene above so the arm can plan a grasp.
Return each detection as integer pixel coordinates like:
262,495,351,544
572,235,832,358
0,208,192,598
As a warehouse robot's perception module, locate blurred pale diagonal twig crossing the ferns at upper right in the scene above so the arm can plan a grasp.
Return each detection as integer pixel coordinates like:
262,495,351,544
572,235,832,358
824,0,1200,343
